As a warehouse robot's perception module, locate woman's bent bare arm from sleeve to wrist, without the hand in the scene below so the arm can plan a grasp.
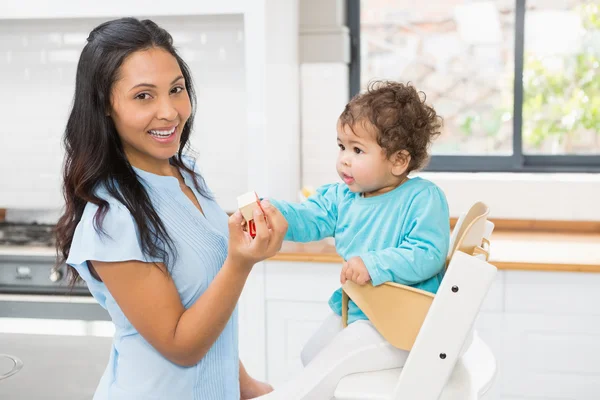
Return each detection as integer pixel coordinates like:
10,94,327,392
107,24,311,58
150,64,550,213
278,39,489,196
92,259,250,366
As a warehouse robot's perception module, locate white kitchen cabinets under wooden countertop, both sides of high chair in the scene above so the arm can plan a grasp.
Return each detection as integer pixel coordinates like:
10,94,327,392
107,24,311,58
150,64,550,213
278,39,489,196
240,261,600,400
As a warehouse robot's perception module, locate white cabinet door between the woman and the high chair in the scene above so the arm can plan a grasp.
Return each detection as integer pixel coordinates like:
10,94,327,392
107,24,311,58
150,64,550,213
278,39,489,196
265,262,341,385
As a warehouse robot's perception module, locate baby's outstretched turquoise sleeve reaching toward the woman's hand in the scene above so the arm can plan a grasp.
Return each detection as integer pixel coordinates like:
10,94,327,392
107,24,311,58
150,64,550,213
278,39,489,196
268,184,338,242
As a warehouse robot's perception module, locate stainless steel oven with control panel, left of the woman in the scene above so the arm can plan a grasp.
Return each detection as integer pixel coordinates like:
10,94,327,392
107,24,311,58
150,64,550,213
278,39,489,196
0,245,114,400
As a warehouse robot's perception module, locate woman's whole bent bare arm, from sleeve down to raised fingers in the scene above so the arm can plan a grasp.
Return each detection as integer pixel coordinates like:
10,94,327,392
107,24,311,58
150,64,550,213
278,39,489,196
92,205,287,366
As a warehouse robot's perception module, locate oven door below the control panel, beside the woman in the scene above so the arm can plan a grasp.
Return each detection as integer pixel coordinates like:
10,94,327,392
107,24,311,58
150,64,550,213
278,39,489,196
0,294,114,400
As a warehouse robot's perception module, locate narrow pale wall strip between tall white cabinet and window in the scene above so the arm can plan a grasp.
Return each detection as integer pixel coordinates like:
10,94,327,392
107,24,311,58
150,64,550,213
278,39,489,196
300,0,350,188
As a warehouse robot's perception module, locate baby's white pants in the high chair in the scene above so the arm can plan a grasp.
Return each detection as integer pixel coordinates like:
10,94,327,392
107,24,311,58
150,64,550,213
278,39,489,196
260,313,408,400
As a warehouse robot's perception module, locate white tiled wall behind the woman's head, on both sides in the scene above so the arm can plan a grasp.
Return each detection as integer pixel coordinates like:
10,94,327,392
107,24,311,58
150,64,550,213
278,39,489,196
0,15,247,208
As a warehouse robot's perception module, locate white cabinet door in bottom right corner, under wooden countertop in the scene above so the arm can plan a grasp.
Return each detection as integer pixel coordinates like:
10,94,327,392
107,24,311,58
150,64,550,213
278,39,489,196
502,271,600,400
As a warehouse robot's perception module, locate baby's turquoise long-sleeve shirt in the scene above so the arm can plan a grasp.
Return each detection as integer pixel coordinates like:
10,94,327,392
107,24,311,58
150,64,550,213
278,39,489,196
270,177,450,323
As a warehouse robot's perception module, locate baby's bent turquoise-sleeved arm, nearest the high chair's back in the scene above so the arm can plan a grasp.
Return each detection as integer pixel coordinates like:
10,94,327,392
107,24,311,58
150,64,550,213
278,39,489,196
360,187,450,286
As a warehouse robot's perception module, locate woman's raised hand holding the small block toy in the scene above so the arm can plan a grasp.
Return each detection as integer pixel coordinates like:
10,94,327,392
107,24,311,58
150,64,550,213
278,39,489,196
227,200,288,269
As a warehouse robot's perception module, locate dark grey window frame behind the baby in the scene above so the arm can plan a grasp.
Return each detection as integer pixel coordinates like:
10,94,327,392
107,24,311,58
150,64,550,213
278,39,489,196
346,0,600,173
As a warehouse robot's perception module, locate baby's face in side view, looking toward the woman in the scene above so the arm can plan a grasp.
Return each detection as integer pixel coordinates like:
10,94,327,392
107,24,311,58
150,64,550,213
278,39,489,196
337,121,401,197
